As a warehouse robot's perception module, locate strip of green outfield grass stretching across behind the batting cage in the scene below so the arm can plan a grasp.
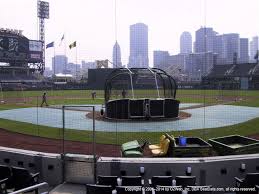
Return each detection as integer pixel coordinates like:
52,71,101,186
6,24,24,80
0,89,259,107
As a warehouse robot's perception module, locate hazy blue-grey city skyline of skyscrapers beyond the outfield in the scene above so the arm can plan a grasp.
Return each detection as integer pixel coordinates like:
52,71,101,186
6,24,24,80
52,23,259,72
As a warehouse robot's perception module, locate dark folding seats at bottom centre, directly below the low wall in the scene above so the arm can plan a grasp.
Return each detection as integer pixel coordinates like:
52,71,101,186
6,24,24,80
95,175,213,194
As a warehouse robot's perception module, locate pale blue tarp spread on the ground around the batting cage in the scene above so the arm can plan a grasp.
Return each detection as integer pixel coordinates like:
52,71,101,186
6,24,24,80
0,104,259,132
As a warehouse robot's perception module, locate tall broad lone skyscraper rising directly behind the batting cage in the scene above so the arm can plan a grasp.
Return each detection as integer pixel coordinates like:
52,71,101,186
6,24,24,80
128,23,149,67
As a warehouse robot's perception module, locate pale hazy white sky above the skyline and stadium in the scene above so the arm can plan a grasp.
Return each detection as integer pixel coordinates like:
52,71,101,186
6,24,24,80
0,0,259,67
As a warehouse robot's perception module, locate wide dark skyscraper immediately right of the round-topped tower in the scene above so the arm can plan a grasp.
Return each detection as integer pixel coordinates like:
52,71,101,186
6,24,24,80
194,27,217,53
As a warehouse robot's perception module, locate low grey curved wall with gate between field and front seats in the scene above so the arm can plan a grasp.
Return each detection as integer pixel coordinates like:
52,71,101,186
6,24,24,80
0,147,259,187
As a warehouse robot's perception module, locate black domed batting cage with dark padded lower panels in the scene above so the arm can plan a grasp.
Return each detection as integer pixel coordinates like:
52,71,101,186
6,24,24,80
104,68,180,120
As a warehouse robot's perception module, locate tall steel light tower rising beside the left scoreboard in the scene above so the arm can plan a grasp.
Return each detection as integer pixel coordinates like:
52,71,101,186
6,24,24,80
38,0,49,74
